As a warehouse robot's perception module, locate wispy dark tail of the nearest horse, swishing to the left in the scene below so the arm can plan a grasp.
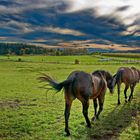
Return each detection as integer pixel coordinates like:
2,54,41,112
38,74,72,92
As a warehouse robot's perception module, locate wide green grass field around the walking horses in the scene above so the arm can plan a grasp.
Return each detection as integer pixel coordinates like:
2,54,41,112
0,55,140,140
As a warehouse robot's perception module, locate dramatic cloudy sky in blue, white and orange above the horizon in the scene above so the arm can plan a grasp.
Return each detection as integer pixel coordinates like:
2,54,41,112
0,0,140,47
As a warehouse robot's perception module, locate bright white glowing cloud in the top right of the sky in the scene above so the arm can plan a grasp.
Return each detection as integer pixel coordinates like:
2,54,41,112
67,0,140,32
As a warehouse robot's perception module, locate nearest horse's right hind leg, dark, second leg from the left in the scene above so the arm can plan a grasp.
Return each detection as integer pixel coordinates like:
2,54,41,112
82,101,91,128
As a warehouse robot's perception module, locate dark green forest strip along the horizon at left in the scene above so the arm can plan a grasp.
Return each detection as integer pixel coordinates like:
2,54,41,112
0,43,88,55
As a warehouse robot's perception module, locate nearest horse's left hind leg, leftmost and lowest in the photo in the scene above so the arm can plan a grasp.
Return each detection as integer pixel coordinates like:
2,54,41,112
64,100,72,136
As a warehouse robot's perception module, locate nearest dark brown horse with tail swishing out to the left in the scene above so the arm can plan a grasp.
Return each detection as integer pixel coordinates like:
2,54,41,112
39,71,111,136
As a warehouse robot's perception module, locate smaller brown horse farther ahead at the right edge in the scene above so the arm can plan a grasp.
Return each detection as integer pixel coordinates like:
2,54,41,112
112,67,140,105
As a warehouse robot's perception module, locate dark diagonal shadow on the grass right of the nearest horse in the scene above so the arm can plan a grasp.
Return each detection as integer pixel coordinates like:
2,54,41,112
73,100,140,140
